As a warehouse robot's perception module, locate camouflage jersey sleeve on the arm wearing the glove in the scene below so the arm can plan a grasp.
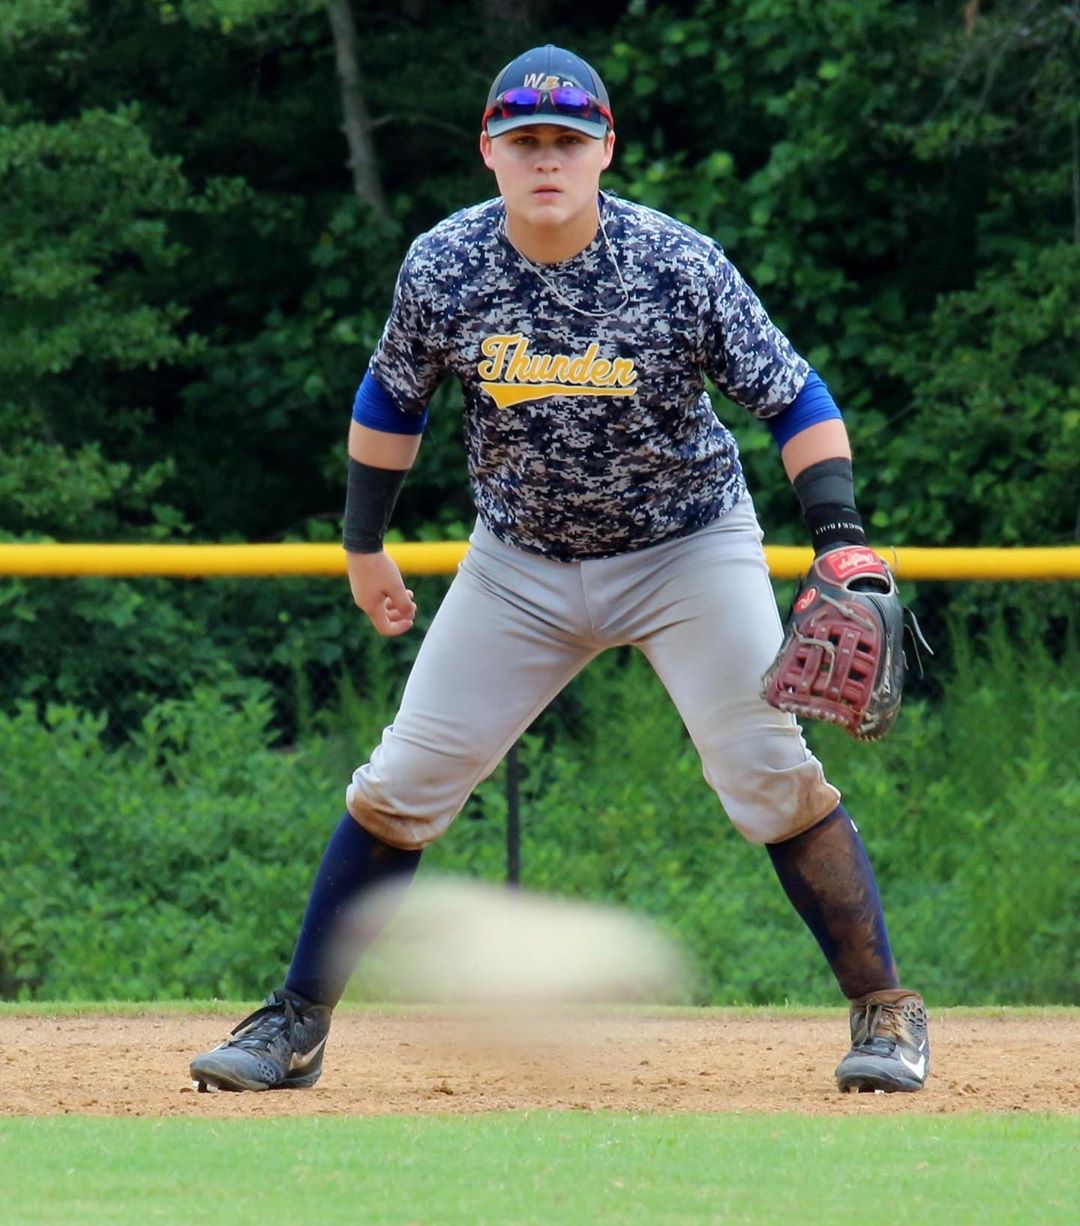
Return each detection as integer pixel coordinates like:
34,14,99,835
700,248,810,418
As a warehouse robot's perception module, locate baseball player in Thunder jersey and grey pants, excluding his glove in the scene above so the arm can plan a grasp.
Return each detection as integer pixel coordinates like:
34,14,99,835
191,45,929,1091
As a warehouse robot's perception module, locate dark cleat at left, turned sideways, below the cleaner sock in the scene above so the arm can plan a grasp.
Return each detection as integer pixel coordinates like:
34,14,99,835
191,988,331,1094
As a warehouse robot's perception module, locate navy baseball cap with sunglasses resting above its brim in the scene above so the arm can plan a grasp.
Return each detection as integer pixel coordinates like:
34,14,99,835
484,43,614,140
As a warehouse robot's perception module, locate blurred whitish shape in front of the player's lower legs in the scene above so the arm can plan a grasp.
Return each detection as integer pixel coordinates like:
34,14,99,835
342,874,694,1005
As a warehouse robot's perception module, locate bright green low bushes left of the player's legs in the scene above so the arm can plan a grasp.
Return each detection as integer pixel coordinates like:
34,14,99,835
0,683,341,998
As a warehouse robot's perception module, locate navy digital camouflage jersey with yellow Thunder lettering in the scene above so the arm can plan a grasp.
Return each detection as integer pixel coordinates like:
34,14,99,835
370,192,809,562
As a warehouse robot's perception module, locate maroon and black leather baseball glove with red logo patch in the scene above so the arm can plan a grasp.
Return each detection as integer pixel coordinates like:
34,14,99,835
762,546,930,741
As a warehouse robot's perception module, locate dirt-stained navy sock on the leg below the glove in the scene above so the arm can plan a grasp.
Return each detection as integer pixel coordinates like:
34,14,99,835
767,805,900,999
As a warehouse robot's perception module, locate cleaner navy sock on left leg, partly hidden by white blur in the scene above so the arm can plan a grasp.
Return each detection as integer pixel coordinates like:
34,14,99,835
284,813,420,1008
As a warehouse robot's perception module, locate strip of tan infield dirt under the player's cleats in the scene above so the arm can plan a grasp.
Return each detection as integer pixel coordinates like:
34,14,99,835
0,1009,1080,1118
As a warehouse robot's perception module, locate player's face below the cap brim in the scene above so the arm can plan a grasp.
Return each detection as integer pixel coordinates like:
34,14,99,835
481,124,615,245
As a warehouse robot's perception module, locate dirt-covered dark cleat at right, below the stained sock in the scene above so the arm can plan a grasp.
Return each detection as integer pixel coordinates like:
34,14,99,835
836,988,930,1094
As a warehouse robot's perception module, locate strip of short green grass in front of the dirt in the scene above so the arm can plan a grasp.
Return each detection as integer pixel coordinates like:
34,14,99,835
0,1113,1080,1226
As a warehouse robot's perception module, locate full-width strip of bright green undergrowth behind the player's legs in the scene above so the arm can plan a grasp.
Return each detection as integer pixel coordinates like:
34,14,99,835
0,613,1080,1004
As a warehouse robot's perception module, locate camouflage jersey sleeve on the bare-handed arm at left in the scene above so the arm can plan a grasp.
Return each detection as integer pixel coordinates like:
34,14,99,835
368,240,446,413
